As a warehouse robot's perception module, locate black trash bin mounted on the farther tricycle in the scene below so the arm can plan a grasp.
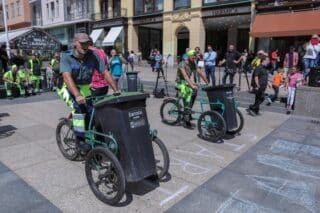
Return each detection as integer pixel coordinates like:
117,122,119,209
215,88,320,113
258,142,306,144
204,84,238,131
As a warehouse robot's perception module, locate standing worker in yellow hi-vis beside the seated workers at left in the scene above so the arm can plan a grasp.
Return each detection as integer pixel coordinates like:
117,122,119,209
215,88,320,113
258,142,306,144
27,54,42,93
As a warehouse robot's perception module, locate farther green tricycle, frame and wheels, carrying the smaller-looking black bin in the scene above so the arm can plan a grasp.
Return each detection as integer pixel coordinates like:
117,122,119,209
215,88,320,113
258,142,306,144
160,85,244,141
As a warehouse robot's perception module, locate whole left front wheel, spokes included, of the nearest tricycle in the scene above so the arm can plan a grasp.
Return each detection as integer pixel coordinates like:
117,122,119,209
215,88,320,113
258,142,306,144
85,147,125,205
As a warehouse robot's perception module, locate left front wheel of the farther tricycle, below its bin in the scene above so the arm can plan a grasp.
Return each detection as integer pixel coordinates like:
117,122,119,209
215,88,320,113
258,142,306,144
198,111,226,141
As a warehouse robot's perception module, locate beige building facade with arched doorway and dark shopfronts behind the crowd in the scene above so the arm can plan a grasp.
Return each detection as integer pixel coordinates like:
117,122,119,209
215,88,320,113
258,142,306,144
92,0,254,63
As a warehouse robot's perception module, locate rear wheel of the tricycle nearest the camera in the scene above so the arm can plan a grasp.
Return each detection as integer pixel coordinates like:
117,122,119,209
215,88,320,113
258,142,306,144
56,118,78,160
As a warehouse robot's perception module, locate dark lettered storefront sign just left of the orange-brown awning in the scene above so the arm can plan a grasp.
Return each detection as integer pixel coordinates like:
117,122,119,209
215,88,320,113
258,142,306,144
202,7,251,17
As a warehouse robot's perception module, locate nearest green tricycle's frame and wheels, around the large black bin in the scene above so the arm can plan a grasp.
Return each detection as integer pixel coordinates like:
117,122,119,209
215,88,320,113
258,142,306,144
56,93,170,205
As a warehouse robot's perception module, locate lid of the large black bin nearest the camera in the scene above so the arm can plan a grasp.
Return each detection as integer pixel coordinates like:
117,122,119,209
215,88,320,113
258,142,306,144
93,92,149,108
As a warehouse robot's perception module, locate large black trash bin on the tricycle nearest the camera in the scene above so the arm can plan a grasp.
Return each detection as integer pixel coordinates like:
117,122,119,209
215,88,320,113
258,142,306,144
94,92,156,182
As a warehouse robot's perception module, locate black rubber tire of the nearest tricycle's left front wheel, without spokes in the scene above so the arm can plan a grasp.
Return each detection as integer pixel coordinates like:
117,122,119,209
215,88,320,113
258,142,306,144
85,147,126,205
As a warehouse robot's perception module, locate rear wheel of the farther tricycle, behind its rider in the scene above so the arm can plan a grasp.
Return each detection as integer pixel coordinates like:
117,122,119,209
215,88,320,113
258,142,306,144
160,99,182,125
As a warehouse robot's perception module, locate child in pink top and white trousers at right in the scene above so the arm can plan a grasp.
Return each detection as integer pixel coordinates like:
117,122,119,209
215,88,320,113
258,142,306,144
286,67,303,114
